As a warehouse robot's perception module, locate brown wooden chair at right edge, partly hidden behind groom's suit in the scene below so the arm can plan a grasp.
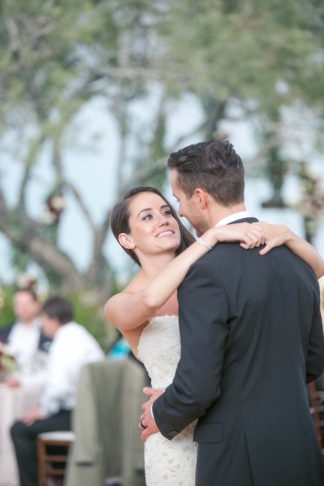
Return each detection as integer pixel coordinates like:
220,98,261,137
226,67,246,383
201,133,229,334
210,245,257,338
308,373,324,459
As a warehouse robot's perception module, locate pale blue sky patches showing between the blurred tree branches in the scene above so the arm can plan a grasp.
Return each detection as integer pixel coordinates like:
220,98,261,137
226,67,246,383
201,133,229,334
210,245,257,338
0,92,324,288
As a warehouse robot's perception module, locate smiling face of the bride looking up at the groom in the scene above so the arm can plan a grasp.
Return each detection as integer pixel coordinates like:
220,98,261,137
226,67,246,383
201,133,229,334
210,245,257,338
120,192,180,258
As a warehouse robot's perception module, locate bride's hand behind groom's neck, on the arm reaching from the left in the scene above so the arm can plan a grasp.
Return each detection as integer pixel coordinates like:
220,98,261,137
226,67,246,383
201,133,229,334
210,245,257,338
202,222,266,249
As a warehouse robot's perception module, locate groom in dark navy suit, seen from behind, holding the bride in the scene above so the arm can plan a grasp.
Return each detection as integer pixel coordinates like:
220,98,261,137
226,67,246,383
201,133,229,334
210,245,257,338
141,142,324,486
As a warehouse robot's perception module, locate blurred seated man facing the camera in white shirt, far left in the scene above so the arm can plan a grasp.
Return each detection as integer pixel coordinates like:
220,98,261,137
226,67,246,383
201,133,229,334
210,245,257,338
0,288,51,387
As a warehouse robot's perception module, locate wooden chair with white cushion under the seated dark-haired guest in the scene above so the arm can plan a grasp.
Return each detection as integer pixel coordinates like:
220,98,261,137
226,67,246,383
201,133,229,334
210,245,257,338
37,431,74,486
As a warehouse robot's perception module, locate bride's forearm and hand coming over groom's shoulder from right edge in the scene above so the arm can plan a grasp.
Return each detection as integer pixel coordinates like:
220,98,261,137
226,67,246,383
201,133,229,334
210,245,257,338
260,222,324,278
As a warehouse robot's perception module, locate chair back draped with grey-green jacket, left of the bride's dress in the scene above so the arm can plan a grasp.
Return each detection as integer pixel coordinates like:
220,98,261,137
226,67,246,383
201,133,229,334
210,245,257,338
65,358,146,486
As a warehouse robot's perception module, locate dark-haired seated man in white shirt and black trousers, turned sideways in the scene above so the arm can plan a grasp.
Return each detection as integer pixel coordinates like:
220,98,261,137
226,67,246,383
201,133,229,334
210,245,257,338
11,297,104,486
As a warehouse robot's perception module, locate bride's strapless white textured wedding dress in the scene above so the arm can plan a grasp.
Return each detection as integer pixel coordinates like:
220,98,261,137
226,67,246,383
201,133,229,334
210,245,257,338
138,316,197,486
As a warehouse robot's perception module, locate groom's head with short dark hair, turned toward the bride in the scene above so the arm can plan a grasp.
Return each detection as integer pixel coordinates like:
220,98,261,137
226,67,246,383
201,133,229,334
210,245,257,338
168,141,244,235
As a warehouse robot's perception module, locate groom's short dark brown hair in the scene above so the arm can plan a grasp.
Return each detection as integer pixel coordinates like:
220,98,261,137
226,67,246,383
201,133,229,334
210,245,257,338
168,140,244,206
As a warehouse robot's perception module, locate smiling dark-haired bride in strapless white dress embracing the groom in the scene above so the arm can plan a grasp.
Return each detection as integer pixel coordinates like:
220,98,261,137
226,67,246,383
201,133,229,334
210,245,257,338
105,187,324,486
